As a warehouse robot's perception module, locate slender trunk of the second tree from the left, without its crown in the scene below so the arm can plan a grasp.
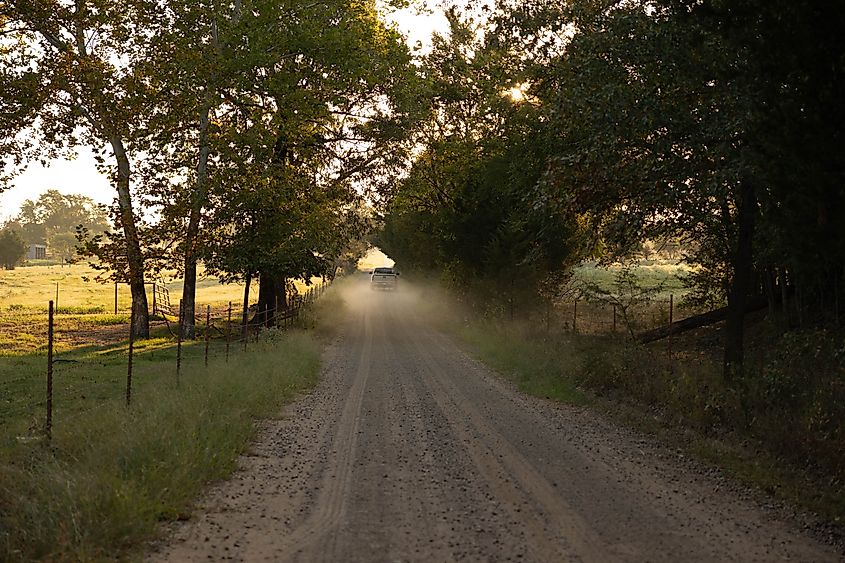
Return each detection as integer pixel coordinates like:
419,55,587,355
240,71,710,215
182,101,211,339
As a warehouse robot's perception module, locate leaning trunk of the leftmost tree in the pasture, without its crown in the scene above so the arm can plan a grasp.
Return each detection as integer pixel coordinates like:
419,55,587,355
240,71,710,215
109,136,150,338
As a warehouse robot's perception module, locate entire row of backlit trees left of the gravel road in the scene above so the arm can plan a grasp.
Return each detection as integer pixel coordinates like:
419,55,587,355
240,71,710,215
0,0,415,338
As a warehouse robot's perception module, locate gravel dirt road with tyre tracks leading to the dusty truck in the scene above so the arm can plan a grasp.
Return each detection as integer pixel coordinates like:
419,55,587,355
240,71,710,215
151,284,840,562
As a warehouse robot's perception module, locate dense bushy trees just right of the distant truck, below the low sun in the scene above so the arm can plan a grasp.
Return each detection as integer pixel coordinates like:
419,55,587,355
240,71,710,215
377,12,579,312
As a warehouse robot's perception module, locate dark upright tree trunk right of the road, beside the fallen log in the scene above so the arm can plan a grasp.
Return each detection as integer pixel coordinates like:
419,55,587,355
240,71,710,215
724,181,757,381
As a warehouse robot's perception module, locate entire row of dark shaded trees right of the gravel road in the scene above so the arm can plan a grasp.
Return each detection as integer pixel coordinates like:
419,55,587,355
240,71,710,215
379,0,845,378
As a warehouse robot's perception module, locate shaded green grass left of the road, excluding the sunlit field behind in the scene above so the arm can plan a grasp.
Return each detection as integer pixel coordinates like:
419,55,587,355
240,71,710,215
0,324,320,561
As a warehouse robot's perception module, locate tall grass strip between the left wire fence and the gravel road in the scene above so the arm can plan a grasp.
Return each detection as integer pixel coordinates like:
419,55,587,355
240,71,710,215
0,331,319,561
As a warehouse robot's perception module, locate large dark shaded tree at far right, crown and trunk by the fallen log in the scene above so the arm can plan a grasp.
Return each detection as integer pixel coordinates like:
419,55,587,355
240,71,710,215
538,0,845,378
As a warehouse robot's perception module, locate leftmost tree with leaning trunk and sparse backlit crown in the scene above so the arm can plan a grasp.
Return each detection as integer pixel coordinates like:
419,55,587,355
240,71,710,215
0,0,159,337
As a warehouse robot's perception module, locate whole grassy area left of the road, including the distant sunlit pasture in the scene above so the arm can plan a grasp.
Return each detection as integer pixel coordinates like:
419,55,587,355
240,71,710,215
0,266,341,561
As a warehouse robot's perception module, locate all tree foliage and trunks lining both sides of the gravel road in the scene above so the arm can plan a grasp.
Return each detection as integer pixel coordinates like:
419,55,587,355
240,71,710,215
0,0,845,376
